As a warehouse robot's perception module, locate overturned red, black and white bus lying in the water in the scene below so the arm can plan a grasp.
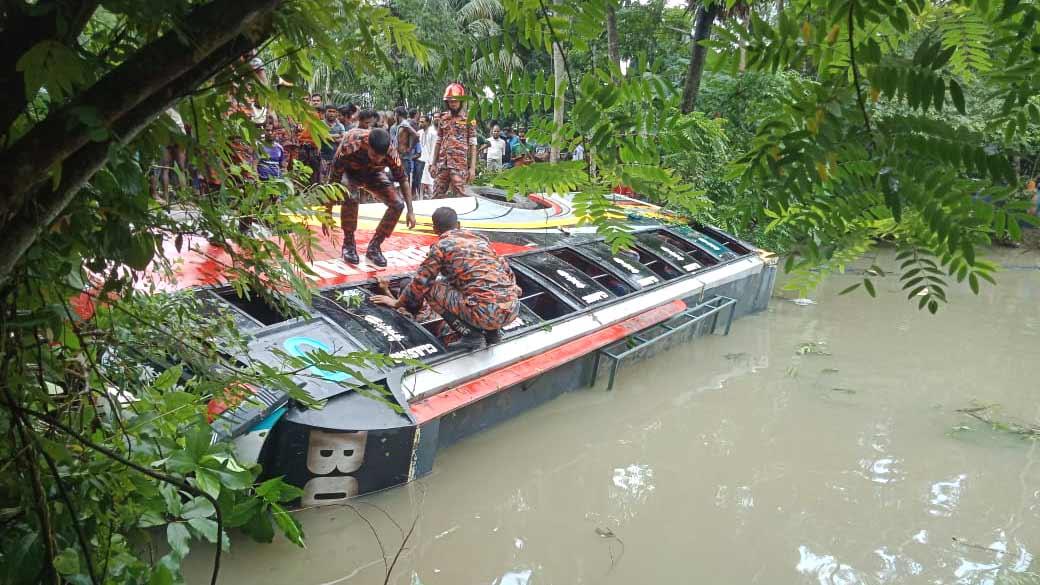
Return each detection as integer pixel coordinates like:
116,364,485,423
172,190,776,506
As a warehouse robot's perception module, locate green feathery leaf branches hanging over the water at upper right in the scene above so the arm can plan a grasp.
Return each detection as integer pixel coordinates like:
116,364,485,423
716,0,1036,306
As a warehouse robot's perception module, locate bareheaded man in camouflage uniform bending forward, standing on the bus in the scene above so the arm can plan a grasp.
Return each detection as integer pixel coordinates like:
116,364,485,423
321,128,415,268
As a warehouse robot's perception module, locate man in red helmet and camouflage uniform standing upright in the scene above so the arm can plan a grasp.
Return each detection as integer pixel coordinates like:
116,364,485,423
430,83,476,199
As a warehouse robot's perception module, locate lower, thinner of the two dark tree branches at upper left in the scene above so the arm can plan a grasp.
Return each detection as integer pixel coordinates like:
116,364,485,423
0,31,264,286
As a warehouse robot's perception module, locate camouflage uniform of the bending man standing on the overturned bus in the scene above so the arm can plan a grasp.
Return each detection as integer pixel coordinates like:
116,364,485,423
332,128,408,239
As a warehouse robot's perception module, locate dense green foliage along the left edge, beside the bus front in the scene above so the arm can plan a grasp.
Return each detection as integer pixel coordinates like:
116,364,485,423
0,0,425,585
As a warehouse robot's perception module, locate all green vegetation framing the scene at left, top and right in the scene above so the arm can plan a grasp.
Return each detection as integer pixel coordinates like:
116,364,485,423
0,0,1040,585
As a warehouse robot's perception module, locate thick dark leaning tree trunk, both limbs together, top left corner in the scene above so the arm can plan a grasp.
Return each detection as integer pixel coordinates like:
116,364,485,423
0,0,280,286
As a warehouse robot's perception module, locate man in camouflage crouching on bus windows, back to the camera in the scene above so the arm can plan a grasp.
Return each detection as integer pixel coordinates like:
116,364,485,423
372,207,520,350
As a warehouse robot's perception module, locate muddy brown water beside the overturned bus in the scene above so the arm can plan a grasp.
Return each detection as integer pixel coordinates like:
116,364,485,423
186,247,1040,585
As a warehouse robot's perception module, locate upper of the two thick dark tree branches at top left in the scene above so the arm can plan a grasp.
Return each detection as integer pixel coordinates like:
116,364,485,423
0,0,281,220
